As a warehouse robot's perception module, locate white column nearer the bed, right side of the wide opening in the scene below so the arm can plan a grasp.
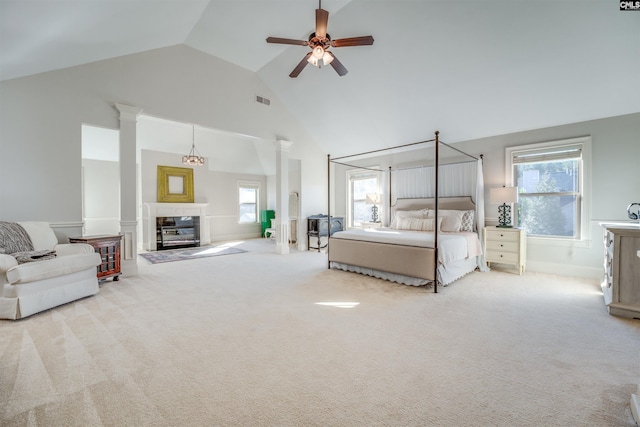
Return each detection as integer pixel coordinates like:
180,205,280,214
275,139,293,255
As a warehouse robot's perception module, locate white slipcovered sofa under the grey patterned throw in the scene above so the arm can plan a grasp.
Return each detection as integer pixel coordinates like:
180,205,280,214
0,221,101,319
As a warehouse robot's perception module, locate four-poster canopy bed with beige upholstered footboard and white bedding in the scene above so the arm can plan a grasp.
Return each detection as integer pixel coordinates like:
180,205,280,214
327,132,487,292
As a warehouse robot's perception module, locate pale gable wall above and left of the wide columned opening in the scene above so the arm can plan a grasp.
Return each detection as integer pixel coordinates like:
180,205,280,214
0,45,323,239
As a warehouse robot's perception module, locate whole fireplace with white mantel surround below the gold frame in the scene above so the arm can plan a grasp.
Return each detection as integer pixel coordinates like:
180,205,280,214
143,203,211,251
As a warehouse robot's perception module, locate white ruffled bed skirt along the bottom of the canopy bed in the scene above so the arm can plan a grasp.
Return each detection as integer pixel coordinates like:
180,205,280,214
331,257,478,286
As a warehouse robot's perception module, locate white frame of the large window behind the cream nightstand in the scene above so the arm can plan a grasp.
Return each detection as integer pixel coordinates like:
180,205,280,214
505,136,591,247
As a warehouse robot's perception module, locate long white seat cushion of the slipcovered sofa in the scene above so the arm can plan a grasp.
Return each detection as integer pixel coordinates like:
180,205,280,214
7,252,102,284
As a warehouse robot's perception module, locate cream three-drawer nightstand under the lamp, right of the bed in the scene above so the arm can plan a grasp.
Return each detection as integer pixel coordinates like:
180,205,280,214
484,226,527,274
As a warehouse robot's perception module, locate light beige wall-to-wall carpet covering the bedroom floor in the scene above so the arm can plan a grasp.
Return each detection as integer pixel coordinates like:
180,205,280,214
0,239,640,427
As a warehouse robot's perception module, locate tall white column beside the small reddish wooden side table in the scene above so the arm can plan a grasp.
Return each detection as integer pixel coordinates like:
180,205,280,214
115,104,142,276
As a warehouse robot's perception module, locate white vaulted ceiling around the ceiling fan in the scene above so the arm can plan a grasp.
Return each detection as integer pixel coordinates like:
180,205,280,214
0,0,640,160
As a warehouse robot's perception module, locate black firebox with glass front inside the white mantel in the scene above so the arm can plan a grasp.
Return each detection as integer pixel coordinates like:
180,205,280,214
156,216,200,251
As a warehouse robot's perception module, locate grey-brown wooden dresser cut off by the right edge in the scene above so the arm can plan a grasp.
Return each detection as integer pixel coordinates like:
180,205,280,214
601,223,640,319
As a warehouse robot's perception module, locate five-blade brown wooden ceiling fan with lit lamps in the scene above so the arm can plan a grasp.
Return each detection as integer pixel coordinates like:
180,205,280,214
267,0,373,78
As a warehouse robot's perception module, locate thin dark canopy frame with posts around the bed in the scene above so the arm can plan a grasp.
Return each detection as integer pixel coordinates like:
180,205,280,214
327,131,483,293
